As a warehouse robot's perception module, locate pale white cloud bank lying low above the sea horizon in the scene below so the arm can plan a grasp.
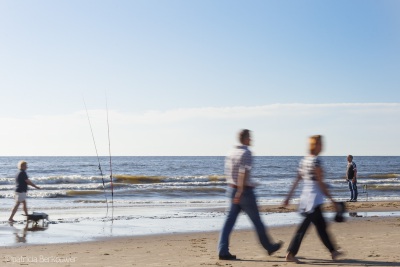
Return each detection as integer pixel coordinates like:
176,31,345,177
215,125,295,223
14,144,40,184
0,103,400,155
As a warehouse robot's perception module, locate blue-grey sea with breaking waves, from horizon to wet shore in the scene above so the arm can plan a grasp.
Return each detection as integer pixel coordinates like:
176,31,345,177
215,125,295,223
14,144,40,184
0,156,400,207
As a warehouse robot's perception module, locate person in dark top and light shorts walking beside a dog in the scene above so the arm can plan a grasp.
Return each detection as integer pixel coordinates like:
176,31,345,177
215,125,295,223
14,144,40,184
8,160,40,222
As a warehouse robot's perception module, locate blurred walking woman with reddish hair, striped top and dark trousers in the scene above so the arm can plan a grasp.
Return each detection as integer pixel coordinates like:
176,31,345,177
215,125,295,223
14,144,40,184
283,135,342,263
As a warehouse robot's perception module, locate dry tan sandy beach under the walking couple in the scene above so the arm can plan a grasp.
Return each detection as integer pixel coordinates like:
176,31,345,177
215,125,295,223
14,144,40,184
0,202,400,266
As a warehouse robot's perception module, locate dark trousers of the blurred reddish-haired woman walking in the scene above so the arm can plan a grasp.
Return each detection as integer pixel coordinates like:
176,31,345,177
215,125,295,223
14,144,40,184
288,206,335,256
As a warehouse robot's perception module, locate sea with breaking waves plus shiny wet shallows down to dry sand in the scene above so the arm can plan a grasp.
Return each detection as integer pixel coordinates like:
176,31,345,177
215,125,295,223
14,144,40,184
0,156,400,246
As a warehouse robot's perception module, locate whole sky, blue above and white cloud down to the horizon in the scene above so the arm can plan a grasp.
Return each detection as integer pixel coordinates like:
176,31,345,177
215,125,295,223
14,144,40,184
0,0,400,156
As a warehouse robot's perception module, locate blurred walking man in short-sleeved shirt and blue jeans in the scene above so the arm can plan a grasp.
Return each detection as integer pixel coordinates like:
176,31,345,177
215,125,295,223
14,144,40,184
218,129,282,260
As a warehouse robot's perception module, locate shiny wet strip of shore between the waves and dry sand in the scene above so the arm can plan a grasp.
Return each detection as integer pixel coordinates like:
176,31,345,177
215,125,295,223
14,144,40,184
0,201,400,247
